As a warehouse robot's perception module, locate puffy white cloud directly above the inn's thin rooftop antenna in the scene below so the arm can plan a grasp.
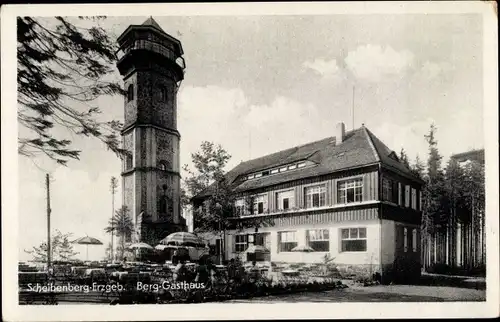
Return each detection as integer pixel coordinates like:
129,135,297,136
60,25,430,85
345,44,414,82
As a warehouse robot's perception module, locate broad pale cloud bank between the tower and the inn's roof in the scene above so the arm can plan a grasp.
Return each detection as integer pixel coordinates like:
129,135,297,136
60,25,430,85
179,86,331,170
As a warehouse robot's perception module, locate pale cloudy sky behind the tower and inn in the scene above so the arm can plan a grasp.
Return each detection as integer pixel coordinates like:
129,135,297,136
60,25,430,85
19,14,484,260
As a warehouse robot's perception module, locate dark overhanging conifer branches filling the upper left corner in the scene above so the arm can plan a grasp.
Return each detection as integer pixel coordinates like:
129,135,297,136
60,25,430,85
17,17,124,165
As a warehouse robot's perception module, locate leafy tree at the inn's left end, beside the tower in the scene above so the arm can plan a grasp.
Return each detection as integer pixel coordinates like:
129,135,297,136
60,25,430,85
184,141,274,262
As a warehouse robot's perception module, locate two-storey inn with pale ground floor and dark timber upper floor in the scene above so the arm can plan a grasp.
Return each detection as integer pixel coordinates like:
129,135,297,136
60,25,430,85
194,123,423,281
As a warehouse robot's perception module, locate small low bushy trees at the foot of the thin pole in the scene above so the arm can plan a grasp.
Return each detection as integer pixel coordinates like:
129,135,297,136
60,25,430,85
24,230,79,262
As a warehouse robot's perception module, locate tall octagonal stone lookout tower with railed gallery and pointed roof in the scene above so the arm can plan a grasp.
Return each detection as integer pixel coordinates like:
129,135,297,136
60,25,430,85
117,18,185,244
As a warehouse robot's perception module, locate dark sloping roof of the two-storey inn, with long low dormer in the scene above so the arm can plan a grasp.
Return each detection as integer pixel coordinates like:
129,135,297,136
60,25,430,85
196,126,419,198
